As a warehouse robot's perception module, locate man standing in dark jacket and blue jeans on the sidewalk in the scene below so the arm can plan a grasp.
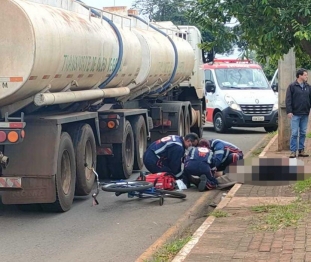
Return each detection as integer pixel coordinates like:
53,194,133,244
286,68,311,158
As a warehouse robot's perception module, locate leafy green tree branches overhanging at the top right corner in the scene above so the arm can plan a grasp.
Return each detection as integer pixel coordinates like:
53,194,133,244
188,0,311,63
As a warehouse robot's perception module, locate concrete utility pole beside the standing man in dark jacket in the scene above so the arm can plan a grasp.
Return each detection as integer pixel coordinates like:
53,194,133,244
278,48,296,151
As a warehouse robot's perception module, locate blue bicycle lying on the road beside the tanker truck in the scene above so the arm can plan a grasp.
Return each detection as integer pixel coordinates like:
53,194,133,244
85,164,186,206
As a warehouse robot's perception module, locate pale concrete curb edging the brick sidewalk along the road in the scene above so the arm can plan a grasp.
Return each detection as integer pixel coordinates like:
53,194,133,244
172,134,275,262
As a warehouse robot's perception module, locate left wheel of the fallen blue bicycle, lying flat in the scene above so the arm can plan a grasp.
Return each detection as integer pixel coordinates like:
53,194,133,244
102,181,153,193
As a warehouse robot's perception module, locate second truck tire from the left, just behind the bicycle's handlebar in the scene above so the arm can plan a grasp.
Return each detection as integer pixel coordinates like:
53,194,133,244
71,123,97,196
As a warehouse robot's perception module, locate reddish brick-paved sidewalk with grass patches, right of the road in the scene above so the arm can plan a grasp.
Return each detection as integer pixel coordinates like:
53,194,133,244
173,120,311,262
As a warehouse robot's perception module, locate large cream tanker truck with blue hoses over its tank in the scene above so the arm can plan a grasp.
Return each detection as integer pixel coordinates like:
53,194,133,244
0,0,205,212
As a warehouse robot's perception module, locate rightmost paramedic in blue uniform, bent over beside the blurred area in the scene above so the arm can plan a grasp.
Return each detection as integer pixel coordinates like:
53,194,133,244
209,139,244,171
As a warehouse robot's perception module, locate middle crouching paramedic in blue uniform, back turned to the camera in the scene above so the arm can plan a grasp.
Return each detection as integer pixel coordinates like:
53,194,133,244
183,139,218,192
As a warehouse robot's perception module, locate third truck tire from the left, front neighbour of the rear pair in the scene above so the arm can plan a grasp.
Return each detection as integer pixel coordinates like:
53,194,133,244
109,120,134,179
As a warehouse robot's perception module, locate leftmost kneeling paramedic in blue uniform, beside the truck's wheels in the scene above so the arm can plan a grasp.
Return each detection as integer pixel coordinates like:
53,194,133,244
143,133,199,178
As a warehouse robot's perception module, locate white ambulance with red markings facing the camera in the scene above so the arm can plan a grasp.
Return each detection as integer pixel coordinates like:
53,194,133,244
202,58,278,133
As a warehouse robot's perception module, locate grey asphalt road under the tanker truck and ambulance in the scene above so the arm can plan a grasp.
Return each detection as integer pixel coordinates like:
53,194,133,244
0,127,266,262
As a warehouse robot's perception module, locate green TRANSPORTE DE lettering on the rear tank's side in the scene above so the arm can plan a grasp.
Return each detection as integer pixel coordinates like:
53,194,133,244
62,55,118,73
